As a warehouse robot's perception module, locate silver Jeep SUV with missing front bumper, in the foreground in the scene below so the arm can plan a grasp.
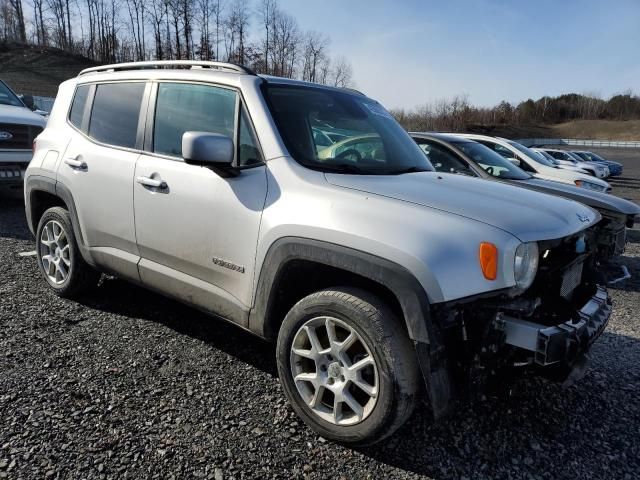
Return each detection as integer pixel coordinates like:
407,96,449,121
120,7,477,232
25,61,611,444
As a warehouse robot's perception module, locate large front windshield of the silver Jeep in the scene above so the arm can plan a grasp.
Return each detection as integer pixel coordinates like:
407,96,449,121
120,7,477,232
264,84,433,175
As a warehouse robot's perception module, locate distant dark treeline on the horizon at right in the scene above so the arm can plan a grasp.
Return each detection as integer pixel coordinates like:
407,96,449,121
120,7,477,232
392,91,640,132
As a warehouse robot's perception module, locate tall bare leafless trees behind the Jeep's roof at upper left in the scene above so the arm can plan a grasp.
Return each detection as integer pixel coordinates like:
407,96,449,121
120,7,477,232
0,0,353,87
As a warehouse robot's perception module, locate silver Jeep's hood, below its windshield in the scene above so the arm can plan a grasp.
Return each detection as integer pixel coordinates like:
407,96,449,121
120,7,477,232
325,172,601,242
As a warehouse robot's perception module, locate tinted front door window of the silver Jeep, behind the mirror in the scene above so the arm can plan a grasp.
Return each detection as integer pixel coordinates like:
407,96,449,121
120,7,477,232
153,83,238,157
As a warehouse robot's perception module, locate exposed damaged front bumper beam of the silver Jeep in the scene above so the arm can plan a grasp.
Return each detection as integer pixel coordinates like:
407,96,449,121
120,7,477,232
498,287,612,367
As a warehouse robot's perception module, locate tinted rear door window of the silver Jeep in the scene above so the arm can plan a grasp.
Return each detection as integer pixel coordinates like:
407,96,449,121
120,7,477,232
89,83,145,148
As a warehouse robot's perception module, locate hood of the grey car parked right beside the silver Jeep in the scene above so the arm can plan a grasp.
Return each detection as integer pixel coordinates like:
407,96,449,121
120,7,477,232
514,178,640,215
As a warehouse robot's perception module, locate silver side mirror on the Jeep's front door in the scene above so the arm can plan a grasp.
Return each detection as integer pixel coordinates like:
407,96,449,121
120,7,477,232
182,132,234,174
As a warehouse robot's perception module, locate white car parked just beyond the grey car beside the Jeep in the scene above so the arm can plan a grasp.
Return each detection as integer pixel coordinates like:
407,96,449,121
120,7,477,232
456,133,611,192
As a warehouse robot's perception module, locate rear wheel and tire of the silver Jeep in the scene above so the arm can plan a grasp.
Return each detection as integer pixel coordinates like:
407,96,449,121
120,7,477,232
36,207,100,298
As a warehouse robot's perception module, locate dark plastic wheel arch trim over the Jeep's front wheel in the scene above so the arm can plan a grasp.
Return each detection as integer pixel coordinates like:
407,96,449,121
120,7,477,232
249,237,433,343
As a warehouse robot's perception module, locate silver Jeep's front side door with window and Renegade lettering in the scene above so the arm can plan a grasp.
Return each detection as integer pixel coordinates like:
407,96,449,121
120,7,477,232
134,82,267,324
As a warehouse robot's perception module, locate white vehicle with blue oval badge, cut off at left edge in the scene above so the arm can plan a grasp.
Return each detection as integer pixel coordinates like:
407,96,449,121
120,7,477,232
0,80,47,189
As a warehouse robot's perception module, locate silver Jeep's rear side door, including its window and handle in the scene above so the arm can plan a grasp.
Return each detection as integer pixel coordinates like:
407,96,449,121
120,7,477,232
57,81,147,279
